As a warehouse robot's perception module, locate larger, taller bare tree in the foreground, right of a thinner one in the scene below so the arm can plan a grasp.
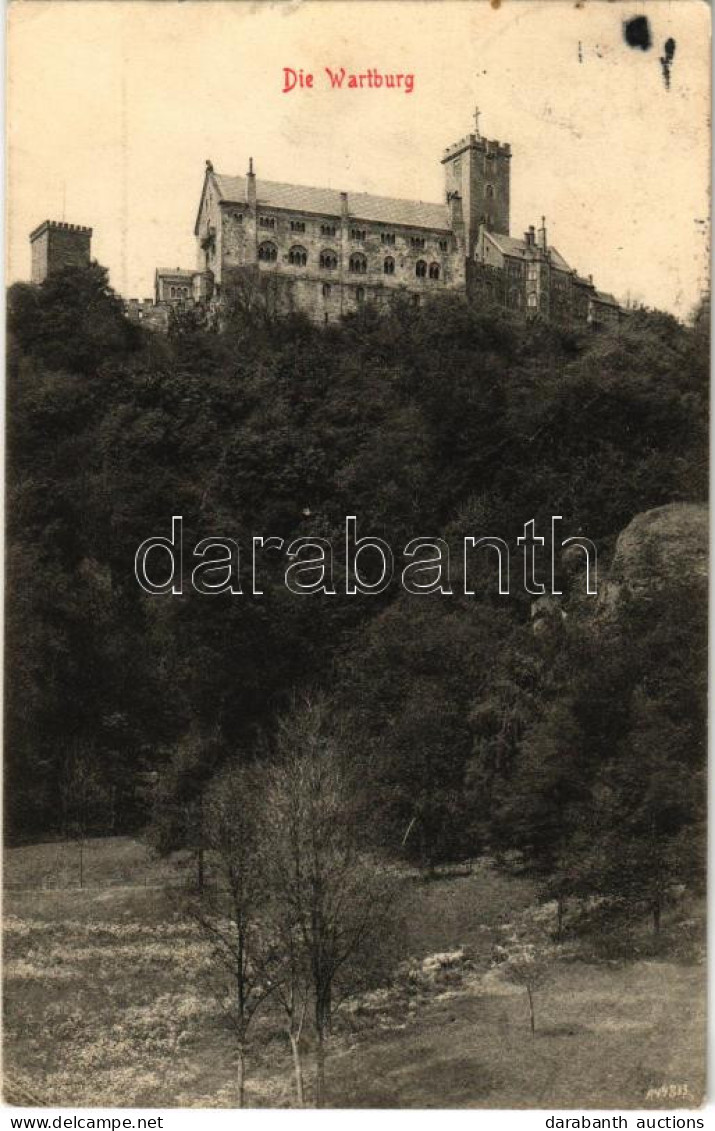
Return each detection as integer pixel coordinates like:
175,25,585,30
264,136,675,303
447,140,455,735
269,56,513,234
267,698,393,1107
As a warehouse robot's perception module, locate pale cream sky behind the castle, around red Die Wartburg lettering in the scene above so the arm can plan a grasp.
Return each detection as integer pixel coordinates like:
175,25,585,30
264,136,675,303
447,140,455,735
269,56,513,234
7,0,710,317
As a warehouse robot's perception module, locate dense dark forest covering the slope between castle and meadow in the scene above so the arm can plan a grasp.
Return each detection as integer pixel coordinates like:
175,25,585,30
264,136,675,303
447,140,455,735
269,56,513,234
5,265,708,917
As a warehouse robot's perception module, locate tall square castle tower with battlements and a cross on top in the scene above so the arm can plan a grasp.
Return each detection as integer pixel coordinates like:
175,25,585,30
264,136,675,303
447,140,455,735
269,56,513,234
442,110,511,259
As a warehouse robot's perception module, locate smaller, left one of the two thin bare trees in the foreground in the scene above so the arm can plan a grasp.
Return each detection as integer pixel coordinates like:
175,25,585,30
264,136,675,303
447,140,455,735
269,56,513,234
189,767,273,1107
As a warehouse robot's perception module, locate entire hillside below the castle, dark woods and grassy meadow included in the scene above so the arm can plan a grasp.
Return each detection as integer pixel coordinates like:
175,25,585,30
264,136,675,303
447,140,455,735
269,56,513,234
5,271,708,1106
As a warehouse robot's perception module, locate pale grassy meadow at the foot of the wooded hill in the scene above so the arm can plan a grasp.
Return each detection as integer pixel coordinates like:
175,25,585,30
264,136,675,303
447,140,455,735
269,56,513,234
5,838,705,1108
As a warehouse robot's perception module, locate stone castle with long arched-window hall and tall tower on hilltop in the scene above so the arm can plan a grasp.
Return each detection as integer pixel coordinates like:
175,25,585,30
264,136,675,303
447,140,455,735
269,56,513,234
31,111,624,328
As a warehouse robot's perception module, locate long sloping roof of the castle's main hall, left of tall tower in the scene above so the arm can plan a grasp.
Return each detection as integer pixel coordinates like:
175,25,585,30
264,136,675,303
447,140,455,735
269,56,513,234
209,173,449,232
